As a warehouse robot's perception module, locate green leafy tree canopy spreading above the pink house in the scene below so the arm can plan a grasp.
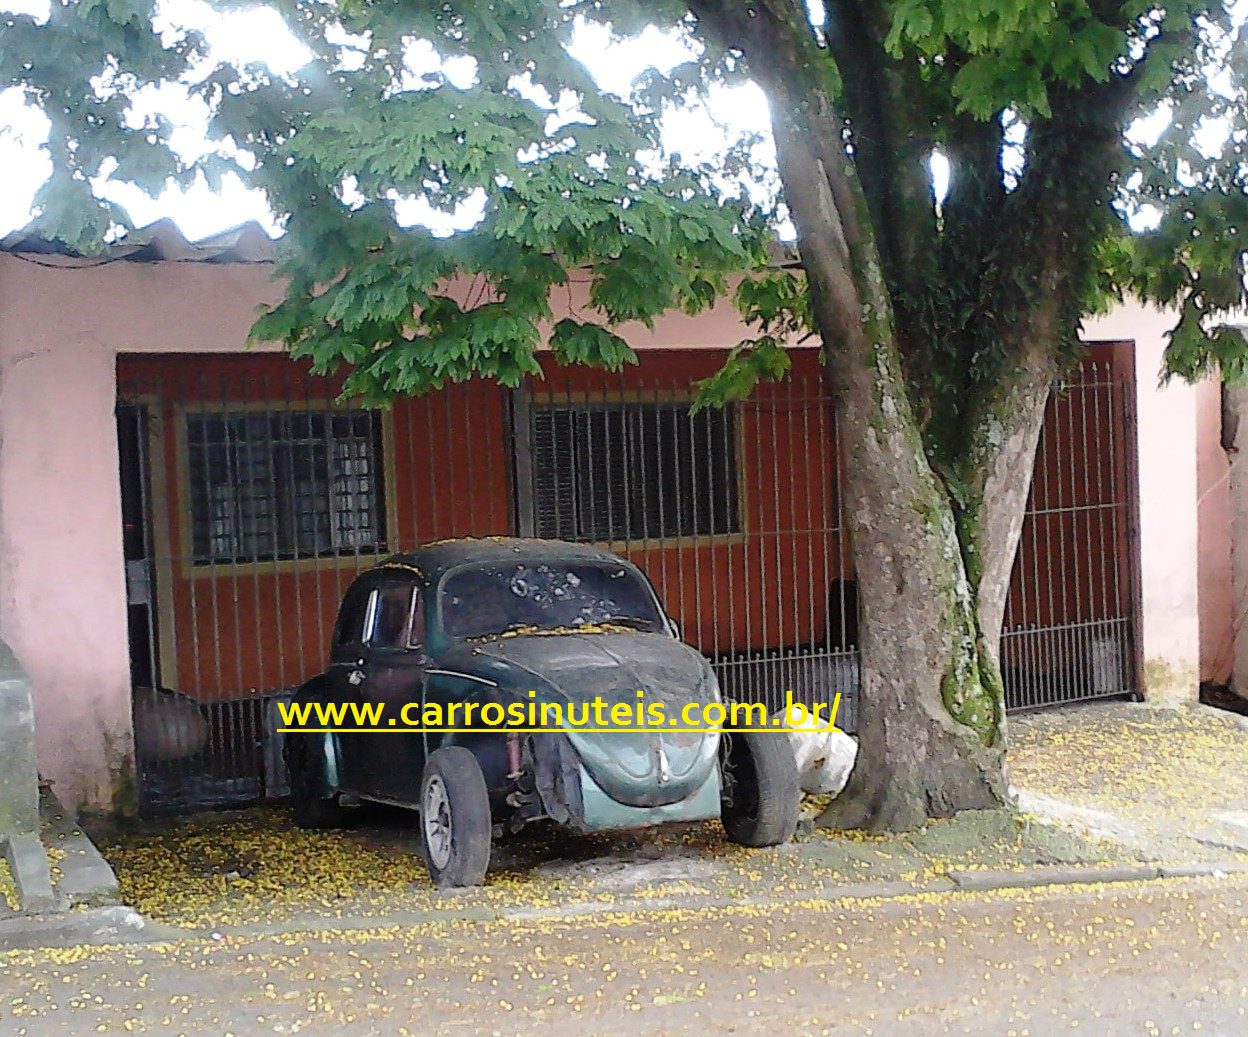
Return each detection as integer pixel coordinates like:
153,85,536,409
0,0,1246,396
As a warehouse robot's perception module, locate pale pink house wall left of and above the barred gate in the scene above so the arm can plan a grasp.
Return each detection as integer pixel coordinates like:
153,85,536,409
0,255,778,807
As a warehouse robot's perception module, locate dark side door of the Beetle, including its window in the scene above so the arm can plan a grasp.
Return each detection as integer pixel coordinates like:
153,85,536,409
361,575,428,805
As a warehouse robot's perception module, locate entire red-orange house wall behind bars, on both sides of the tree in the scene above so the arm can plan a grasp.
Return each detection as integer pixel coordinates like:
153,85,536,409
119,343,1132,699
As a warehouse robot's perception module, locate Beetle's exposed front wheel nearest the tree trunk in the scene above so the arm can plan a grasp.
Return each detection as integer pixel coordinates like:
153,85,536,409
720,731,801,846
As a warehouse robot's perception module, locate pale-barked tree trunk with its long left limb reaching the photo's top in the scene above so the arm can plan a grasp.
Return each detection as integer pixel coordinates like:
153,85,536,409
691,0,1060,829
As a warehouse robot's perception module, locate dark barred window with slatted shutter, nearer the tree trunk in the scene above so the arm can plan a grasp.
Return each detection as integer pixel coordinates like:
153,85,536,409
529,402,740,540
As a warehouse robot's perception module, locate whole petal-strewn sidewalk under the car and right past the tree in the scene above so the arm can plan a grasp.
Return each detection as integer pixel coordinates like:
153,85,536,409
7,704,1248,938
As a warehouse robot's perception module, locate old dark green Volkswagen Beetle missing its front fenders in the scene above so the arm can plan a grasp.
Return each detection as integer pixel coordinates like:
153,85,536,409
286,538,799,886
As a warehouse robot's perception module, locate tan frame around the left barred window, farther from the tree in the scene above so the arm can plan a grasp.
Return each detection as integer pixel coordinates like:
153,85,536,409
175,399,398,580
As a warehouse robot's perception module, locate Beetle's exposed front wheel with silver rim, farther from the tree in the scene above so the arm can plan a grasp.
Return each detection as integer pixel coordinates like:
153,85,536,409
421,745,493,889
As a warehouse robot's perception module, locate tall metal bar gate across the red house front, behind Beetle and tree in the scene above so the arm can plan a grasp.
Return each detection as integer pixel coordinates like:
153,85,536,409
117,348,1137,810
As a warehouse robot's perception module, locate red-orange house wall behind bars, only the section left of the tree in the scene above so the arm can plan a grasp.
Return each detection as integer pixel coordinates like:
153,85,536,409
119,351,845,699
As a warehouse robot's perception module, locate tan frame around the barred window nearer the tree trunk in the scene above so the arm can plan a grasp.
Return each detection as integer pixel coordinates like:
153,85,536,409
512,388,750,552
